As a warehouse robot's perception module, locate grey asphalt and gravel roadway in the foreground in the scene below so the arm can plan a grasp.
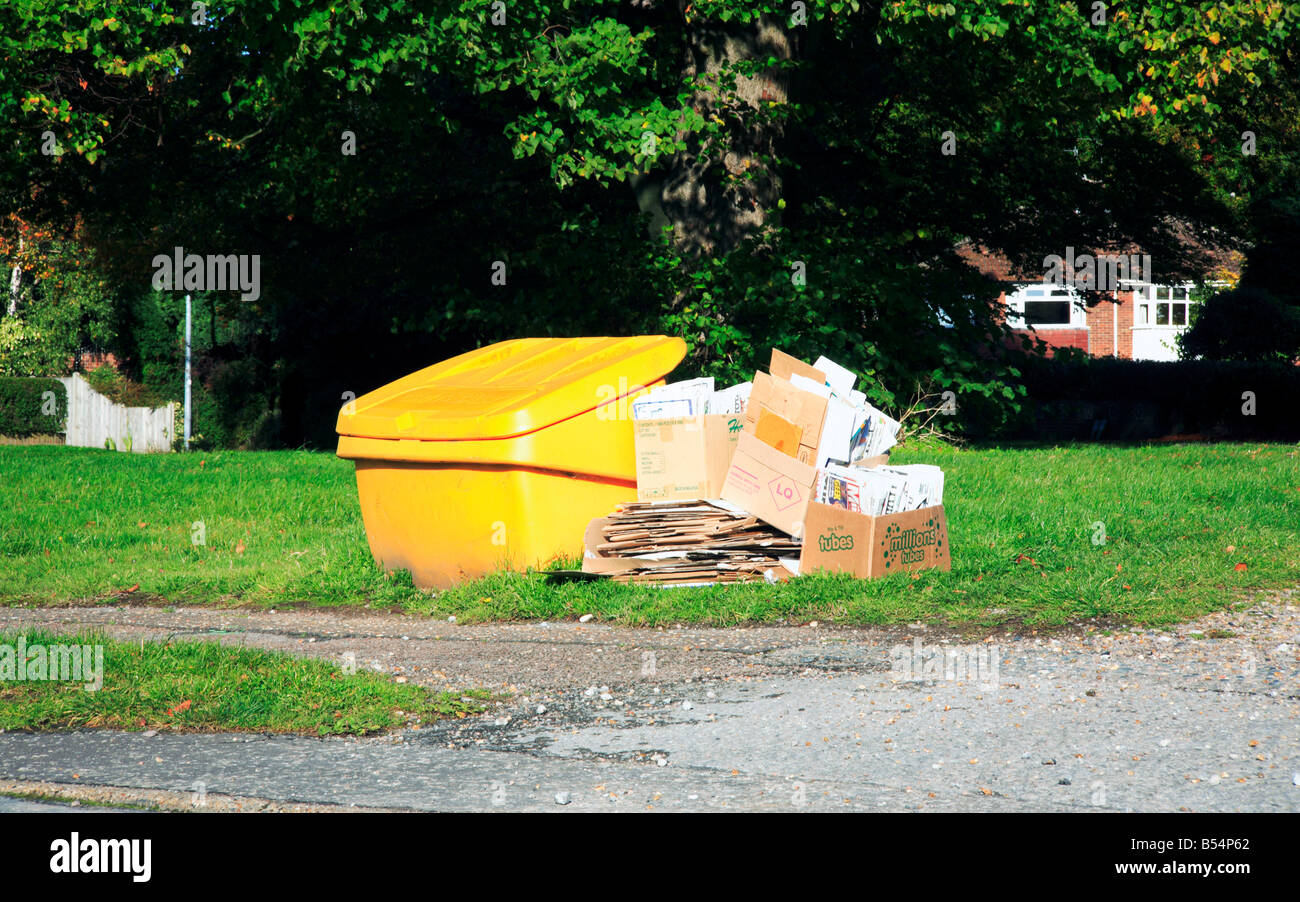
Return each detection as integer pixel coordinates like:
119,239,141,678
0,594,1300,811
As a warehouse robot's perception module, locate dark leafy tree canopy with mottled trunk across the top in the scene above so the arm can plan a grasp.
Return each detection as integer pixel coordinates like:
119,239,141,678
0,0,1300,443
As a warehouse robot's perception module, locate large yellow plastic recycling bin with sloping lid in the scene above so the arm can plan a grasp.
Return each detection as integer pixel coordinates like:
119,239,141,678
337,335,686,589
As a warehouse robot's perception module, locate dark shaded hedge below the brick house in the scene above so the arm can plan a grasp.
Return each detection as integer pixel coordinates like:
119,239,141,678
993,357,1300,441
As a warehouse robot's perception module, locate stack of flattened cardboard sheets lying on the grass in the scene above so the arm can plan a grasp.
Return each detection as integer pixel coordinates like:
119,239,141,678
582,500,801,585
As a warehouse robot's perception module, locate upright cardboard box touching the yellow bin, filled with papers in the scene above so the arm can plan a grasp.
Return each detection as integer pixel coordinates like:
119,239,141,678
633,413,744,502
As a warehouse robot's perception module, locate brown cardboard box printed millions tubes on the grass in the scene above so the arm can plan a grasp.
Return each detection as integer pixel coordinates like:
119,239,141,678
800,502,952,578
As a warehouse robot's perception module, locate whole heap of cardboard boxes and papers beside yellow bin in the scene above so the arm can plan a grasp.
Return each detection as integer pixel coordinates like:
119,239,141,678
582,348,949,585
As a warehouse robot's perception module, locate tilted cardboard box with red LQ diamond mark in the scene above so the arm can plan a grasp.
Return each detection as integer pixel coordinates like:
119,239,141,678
722,432,816,538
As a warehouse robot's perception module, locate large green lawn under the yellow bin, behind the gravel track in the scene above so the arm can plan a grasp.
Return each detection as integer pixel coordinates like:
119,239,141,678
0,445,1300,626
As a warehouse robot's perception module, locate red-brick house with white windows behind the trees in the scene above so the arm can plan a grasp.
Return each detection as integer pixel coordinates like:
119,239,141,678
957,244,1236,360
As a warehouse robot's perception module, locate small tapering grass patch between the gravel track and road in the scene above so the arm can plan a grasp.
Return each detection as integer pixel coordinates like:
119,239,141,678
0,630,488,736
